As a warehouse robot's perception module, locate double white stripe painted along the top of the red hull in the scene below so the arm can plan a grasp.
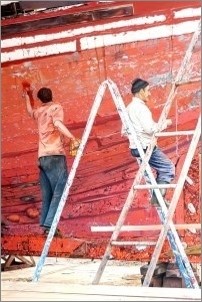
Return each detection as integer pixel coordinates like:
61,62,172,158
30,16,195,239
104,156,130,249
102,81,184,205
1,8,201,63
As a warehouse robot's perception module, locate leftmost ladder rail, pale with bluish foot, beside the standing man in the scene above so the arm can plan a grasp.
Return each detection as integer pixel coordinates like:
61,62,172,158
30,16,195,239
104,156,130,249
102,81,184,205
32,81,107,281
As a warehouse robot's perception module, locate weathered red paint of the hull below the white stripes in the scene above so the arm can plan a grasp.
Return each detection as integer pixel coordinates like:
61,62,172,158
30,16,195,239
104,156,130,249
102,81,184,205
2,2,201,262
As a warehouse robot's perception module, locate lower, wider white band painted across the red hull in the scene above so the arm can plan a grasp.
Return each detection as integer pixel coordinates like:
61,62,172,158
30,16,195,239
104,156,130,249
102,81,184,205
1,20,199,63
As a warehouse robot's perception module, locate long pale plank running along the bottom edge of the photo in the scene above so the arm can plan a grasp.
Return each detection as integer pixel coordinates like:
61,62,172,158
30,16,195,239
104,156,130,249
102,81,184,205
1,281,201,301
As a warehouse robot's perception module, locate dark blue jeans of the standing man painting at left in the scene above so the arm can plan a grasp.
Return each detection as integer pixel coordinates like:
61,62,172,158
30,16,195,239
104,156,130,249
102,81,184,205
39,155,68,228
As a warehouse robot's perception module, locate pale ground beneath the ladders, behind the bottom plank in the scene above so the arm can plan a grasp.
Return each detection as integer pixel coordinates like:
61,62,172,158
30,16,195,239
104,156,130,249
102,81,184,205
1,257,145,286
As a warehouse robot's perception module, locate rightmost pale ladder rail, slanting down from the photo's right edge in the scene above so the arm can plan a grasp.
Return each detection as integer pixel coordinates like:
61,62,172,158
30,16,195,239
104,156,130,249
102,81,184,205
143,117,201,288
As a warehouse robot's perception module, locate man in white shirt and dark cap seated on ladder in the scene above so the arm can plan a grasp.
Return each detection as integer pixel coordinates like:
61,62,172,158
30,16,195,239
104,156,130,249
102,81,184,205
122,78,175,206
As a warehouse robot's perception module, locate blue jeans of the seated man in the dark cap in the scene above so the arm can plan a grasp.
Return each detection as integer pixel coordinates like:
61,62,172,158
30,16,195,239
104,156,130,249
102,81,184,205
131,147,175,183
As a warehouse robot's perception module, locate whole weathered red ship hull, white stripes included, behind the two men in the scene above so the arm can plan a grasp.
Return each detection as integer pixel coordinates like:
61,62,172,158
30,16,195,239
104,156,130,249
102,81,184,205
2,2,201,262
